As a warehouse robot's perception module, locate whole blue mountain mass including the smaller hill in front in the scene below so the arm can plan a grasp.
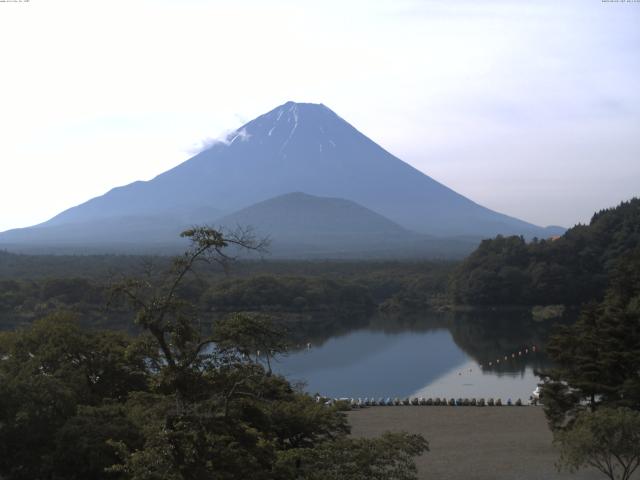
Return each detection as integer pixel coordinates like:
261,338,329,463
0,102,563,256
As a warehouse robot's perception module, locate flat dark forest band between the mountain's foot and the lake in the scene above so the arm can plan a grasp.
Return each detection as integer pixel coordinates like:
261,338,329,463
0,254,454,329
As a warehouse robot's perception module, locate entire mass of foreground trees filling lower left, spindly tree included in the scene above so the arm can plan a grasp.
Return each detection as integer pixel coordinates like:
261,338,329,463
0,228,426,480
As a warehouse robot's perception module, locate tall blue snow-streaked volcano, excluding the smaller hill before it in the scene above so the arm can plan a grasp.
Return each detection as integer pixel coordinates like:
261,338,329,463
0,102,557,253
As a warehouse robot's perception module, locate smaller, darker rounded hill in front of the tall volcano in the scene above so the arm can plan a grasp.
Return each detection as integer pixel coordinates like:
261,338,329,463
216,192,479,258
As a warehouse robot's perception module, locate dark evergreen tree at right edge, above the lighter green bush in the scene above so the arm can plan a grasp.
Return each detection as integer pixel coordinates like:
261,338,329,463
542,248,640,428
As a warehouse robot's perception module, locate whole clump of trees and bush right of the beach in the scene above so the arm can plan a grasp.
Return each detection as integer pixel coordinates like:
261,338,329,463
541,248,640,480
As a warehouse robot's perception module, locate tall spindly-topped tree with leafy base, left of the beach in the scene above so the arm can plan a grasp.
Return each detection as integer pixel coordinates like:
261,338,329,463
111,229,424,480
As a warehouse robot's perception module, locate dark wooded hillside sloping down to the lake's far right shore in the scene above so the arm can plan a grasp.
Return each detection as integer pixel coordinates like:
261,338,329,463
450,199,640,305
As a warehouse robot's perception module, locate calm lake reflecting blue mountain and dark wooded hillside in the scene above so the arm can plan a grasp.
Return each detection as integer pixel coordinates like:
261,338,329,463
274,314,548,401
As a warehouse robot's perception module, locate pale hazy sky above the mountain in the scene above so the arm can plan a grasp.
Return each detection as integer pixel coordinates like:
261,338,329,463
0,0,640,231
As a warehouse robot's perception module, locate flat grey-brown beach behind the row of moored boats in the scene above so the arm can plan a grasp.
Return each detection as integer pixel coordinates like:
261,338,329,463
348,406,628,480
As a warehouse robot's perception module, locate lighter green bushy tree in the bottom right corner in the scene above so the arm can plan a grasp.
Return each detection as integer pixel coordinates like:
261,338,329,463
554,408,640,480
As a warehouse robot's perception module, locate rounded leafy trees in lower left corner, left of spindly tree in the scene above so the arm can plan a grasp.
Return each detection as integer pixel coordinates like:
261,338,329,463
0,314,148,479
